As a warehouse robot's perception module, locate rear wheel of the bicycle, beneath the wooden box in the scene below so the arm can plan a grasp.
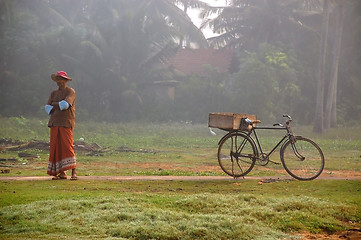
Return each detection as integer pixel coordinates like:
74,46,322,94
218,133,257,177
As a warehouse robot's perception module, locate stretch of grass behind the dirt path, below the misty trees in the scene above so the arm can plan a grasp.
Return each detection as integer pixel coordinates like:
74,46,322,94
0,117,361,176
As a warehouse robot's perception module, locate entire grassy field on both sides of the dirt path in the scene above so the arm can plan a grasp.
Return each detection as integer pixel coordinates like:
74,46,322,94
0,118,361,239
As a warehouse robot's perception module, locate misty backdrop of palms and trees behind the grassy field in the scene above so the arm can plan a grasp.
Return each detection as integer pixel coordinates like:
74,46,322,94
0,0,361,132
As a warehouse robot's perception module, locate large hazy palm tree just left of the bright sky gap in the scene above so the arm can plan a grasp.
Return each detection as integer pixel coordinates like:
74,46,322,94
67,0,207,120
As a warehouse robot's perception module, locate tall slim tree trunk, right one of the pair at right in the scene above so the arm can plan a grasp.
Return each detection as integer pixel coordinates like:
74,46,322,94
325,1,345,129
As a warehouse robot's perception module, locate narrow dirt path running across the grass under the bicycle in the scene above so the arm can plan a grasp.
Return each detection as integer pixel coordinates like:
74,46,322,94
0,176,361,182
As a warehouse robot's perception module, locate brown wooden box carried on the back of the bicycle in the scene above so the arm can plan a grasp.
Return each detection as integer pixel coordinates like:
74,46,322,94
208,113,257,131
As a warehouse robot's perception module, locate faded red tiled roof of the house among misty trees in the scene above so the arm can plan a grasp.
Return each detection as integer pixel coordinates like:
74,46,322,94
168,49,234,75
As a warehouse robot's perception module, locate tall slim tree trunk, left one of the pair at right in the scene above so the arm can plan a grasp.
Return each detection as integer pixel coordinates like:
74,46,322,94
313,0,329,133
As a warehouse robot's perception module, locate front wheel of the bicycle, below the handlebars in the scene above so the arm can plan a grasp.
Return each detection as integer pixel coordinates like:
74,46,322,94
280,136,325,180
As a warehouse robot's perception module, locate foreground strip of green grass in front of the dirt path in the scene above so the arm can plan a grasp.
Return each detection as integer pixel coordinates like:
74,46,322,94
0,180,361,239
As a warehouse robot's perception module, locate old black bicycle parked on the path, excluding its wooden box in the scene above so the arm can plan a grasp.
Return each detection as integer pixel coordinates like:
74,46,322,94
218,115,325,180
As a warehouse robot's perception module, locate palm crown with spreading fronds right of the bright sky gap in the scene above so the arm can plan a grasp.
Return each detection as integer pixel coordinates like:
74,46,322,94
202,0,307,50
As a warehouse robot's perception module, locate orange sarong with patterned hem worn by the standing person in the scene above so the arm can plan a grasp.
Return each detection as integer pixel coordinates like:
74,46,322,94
47,126,76,176
